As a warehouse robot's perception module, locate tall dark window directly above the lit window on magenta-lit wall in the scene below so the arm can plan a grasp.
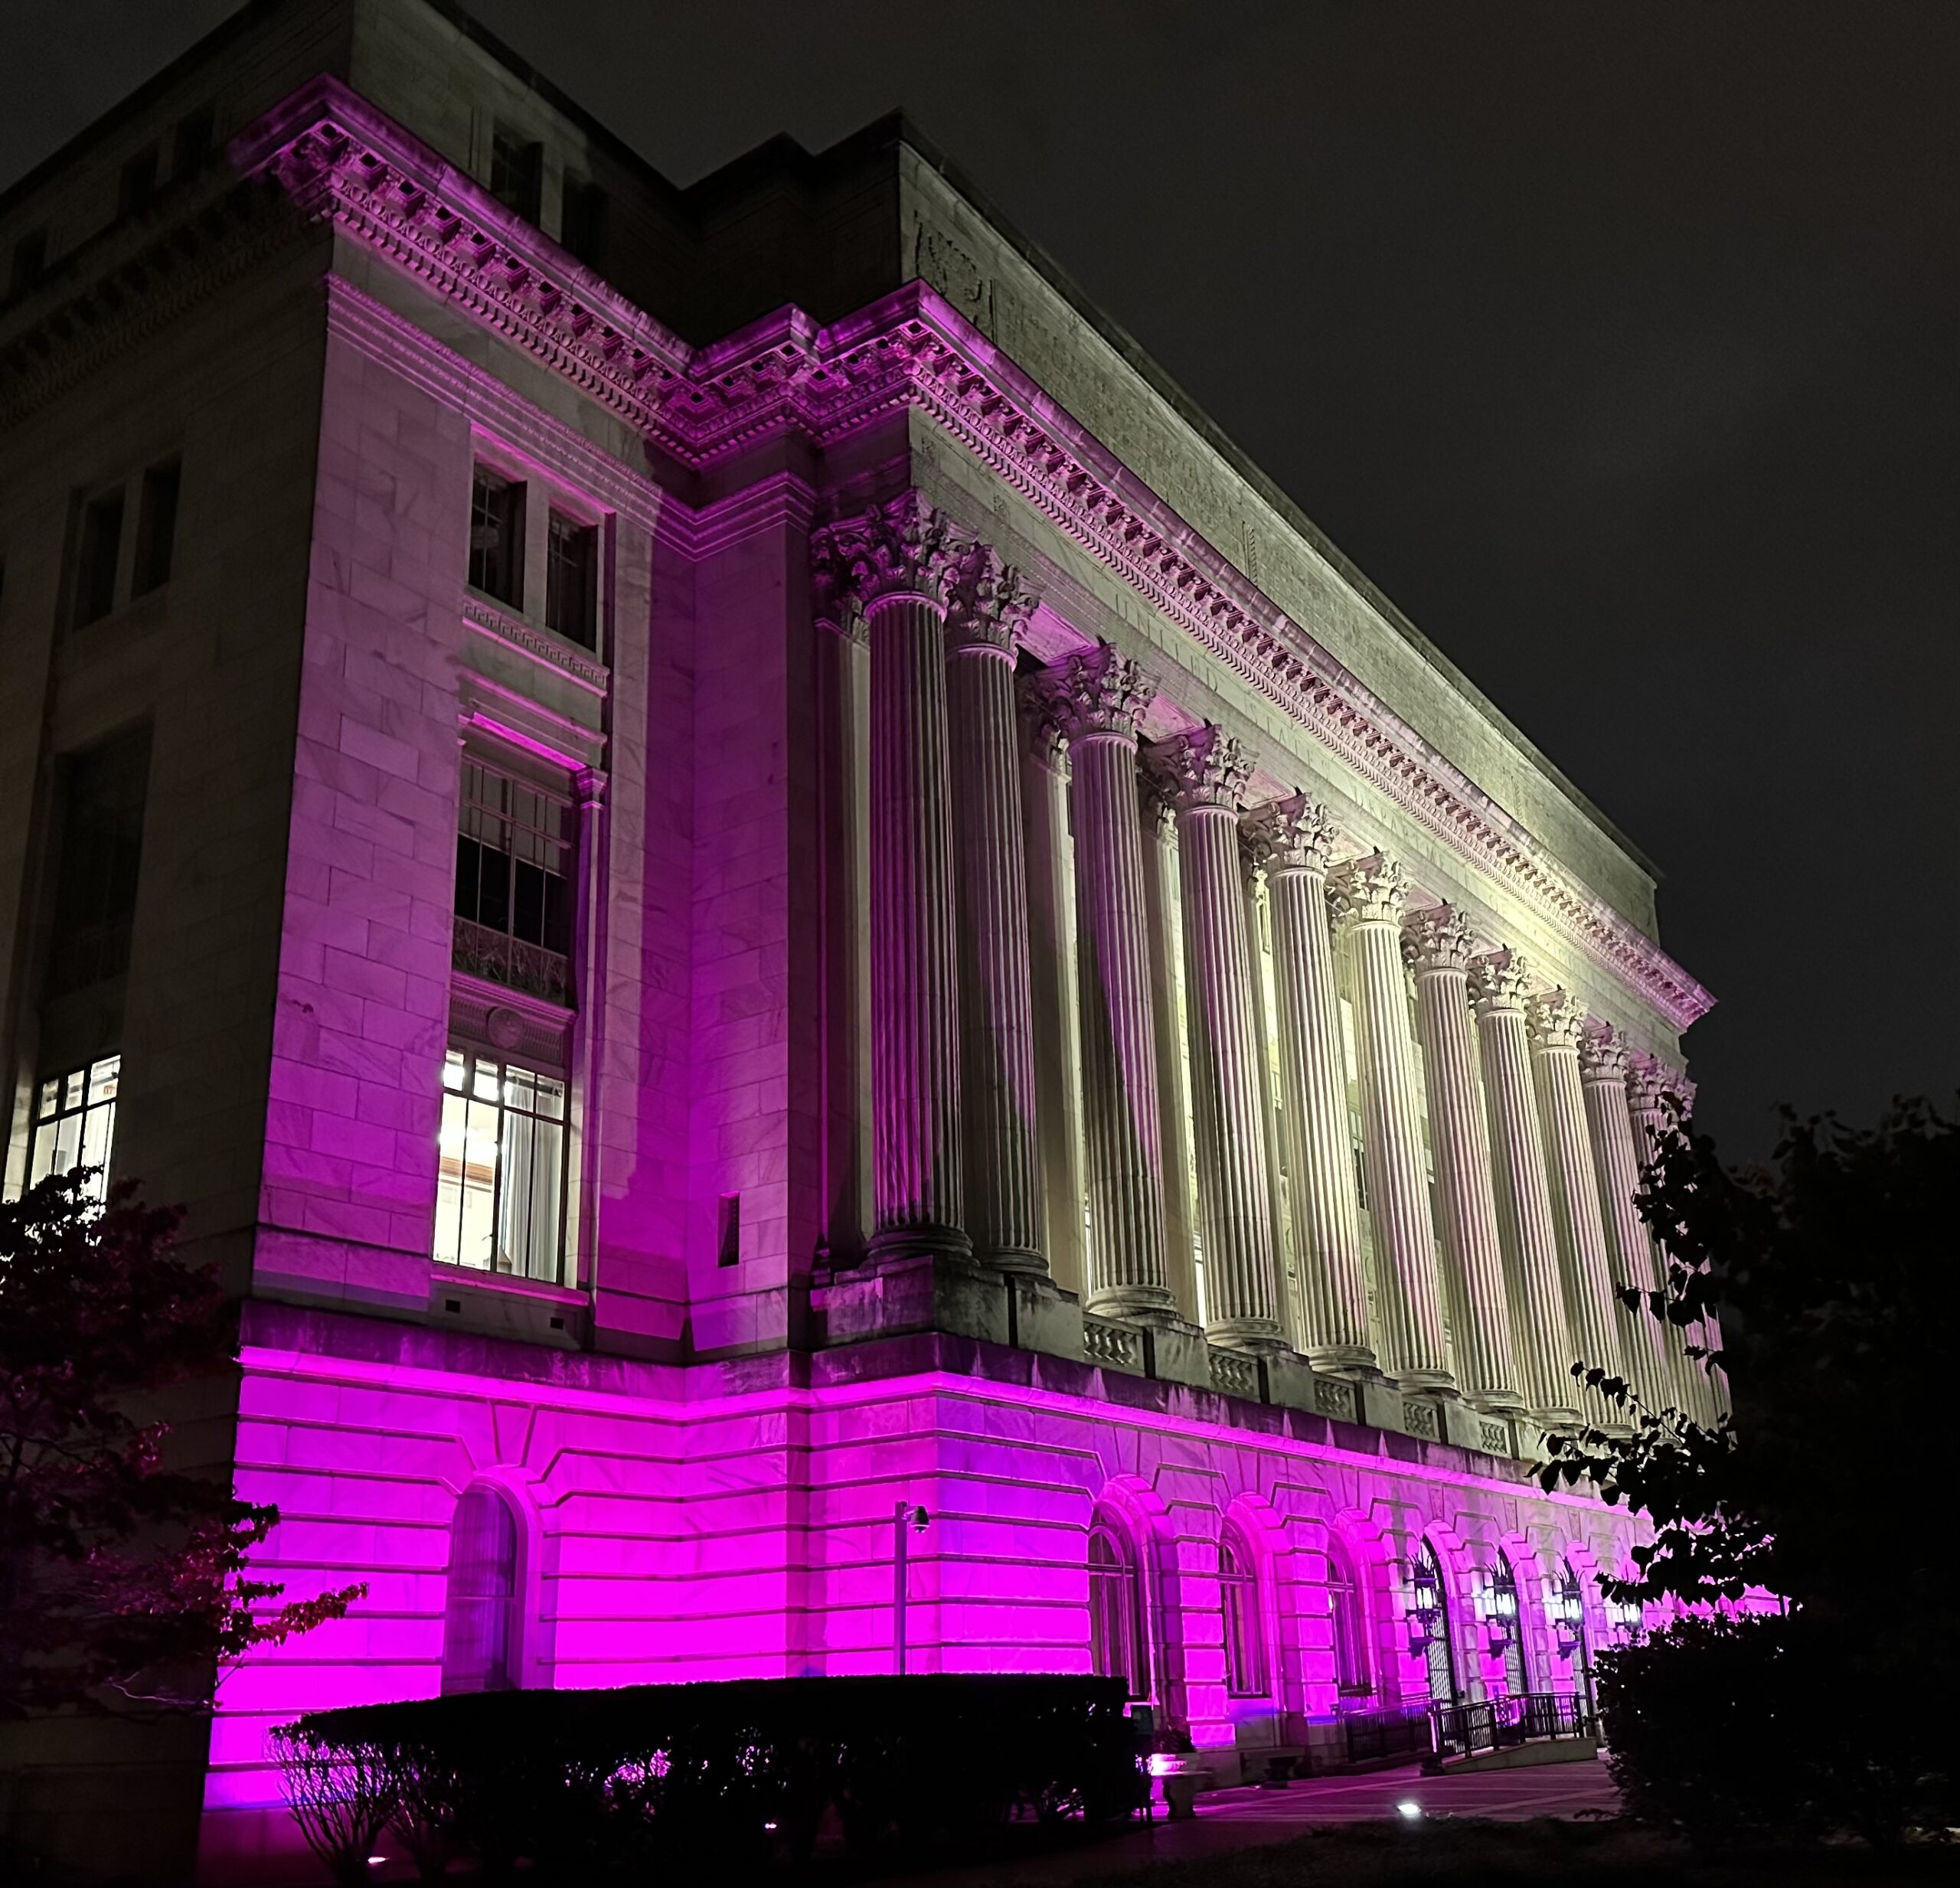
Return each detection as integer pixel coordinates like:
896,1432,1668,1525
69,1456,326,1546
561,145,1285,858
455,756,577,1006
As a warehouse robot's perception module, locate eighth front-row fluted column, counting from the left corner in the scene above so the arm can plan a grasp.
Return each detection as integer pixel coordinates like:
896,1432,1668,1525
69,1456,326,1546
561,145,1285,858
1470,951,1579,1429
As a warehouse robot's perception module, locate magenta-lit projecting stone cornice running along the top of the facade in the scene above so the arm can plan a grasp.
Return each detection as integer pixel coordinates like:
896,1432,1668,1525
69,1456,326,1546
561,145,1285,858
231,78,1713,1029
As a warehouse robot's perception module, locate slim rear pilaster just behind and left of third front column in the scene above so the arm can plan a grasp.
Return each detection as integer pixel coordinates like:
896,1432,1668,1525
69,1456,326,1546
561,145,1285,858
1015,694,1086,1292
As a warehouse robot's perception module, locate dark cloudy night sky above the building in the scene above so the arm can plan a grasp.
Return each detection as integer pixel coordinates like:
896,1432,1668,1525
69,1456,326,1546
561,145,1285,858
0,0,1960,1153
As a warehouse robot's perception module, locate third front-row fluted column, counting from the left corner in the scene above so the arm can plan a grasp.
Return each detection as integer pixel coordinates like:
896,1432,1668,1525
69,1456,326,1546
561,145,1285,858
1049,643,1176,1318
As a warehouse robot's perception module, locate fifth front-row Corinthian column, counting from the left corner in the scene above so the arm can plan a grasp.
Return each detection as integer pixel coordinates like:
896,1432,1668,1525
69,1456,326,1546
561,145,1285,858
1246,794,1374,1370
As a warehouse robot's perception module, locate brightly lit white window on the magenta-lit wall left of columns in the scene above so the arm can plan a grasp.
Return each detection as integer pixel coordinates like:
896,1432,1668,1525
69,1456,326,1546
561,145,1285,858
435,1049,564,1284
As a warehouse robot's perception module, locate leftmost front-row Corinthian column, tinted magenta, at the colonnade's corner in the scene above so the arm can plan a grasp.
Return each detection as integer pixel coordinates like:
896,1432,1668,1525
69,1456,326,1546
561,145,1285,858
819,492,970,1259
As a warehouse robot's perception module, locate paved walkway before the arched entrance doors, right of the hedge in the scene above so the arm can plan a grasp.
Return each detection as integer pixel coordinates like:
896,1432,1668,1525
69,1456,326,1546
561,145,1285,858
892,1761,1619,1888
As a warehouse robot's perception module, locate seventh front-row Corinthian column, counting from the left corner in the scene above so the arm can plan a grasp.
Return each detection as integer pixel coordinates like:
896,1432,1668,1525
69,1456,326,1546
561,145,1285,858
1403,906,1525,1409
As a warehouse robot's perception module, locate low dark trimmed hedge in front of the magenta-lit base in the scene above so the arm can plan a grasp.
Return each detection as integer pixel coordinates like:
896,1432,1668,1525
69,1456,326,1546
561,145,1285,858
276,1676,1145,1880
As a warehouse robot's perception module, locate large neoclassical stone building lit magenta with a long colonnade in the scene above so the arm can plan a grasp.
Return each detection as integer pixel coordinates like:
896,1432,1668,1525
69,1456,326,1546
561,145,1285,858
0,0,1711,1873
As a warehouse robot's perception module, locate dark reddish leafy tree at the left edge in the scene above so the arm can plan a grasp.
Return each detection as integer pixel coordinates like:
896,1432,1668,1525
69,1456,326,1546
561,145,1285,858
0,1171,364,1717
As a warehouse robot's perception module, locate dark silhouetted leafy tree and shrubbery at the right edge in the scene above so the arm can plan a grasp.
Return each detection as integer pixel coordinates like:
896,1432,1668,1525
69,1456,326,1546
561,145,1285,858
1540,1100,1960,1839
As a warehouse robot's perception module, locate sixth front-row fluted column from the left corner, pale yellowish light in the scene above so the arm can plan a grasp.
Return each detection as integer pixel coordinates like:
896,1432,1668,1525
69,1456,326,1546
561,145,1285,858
1334,853,1455,1386
